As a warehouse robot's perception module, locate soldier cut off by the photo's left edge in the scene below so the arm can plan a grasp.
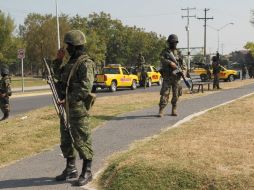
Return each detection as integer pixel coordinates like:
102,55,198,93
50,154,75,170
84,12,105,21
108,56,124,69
0,68,11,121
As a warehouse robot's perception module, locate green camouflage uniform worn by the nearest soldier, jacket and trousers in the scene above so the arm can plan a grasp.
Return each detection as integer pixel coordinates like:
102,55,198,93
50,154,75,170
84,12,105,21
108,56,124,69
56,55,95,160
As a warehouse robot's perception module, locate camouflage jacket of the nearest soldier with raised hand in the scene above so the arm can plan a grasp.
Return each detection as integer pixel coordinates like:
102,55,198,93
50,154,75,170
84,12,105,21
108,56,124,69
53,54,95,117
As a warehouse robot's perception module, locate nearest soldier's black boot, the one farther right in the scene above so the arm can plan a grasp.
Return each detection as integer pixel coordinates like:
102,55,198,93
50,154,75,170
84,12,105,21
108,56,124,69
77,159,93,186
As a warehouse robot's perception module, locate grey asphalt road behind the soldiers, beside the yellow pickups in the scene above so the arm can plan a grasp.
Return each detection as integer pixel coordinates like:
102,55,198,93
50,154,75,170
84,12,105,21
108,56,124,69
0,85,160,118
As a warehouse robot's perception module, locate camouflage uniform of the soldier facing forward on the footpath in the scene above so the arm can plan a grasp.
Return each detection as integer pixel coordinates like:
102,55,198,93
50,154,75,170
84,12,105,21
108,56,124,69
159,35,185,117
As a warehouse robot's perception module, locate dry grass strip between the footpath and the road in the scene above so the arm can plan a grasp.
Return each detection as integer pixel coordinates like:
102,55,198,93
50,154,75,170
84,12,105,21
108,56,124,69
0,80,254,170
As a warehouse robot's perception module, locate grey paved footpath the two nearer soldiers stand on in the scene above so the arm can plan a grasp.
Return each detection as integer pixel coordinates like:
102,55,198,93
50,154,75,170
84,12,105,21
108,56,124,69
0,84,254,190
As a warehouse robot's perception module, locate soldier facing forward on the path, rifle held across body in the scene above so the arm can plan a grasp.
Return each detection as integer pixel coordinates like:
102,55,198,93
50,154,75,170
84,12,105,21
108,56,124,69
159,34,185,117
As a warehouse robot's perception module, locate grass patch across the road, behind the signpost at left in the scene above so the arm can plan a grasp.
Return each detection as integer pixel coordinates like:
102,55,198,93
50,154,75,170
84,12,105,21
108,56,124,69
11,77,47,88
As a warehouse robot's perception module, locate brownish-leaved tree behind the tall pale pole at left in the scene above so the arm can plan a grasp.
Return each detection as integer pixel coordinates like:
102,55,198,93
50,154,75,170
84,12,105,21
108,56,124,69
20,13,70,74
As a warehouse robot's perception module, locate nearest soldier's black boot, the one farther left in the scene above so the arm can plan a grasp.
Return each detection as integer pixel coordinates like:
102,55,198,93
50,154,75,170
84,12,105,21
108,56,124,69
55,158,78,181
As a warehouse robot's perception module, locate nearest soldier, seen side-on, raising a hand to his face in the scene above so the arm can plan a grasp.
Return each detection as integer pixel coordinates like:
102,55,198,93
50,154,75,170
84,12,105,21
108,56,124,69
53,30,95,186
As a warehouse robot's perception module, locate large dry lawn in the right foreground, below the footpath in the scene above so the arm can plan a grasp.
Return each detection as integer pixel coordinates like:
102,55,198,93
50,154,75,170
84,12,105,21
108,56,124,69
97,92,254,190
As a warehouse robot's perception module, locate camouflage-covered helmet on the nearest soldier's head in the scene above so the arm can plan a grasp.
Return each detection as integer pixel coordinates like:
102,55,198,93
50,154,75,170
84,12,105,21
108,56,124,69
64,30,86,46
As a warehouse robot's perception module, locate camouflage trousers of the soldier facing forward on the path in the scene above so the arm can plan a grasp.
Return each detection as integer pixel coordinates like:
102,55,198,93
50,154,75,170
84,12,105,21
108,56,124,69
159,79,182,109
